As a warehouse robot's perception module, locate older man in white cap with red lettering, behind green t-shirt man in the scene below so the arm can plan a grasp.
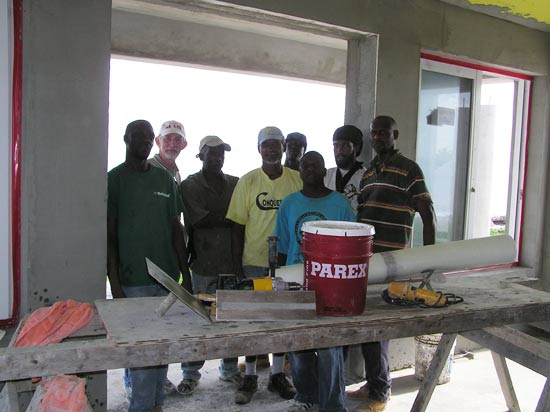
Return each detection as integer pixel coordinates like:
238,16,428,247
149,120,187,185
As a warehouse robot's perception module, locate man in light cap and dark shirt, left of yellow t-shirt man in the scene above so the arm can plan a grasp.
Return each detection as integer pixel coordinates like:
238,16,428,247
177,136,242,396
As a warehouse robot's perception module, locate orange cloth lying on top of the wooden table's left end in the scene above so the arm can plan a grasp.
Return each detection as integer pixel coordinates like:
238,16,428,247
15,299,94,347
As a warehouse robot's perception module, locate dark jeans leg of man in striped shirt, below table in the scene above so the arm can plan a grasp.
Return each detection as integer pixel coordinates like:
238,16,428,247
361,340,391,402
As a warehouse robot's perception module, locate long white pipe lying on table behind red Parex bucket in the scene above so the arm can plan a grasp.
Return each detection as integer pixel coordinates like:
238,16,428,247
275,235,516,284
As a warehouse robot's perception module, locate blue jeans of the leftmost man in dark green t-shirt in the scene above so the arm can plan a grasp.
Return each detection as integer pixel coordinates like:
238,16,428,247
122,285,168,412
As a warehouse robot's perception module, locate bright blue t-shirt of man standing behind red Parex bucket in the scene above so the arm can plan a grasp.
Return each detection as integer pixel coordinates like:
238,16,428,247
275,192,356,265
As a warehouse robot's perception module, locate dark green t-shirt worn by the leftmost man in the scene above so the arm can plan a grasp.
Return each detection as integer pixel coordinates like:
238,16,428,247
107,163,183,286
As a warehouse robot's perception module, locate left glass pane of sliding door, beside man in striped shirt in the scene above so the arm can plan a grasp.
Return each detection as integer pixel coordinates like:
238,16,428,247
413,70,473,246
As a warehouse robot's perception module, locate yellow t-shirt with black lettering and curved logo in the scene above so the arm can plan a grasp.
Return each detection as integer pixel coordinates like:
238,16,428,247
227,167,302,267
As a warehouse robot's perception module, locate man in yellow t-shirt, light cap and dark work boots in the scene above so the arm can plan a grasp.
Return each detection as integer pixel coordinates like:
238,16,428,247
227,126,302,404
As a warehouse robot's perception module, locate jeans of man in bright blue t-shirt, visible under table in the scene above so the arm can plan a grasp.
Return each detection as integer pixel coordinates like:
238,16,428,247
289,346,347,412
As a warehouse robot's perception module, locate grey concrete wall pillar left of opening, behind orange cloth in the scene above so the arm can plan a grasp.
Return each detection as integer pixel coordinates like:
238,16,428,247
21,0,111,411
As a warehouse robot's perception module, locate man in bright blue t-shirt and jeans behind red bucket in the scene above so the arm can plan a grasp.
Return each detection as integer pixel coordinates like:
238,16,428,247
275,152,355,412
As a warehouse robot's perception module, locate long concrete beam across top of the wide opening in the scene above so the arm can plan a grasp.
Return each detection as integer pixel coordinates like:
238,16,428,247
111,10,346,84
